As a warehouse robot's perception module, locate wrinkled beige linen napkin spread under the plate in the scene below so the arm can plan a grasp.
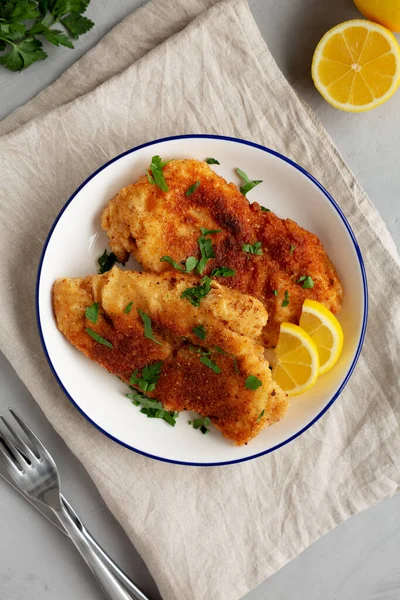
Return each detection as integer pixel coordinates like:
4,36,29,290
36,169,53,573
0,0,400,600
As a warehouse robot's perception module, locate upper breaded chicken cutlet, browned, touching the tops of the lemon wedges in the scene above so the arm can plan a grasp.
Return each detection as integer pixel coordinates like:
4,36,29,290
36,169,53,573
102,159,343,347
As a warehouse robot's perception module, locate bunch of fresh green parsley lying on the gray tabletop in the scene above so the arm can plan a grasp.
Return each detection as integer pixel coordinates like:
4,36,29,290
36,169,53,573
0,0,94,71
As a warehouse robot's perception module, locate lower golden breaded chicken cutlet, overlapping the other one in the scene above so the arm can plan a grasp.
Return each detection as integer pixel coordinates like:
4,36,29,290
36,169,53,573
53,268,288,445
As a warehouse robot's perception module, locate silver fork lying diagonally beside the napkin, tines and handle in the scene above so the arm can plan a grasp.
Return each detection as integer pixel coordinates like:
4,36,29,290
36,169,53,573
0,408,148,600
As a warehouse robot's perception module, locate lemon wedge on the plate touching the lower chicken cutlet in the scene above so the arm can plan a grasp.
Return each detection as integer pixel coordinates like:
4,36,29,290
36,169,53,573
272,323,319,396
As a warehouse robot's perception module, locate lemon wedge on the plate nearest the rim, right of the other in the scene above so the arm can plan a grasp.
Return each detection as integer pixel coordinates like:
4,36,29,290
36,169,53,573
300,300,343,375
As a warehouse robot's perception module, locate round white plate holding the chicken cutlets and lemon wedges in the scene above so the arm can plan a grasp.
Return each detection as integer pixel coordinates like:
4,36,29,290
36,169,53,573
36,135,367,465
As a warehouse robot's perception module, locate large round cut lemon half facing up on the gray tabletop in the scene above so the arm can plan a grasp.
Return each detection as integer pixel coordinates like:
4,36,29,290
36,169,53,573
311,19,400,112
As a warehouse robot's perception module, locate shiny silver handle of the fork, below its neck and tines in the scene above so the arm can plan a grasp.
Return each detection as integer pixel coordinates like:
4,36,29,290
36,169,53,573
53,502,139,600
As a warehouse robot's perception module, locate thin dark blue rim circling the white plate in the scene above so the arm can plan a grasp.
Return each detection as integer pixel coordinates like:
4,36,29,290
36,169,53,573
35,133,368,467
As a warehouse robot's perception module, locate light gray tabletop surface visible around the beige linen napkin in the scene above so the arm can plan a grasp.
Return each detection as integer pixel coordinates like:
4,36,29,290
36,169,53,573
0,0,400,600
